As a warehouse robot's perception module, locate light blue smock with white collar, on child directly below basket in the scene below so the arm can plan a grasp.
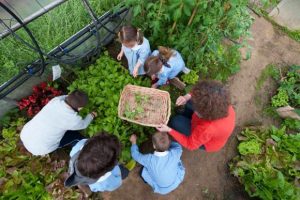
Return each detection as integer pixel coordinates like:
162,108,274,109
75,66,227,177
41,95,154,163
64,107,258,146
131,142,185,194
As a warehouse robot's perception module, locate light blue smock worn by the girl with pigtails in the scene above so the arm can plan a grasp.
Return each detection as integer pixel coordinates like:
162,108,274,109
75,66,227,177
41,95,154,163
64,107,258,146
122,38,151,75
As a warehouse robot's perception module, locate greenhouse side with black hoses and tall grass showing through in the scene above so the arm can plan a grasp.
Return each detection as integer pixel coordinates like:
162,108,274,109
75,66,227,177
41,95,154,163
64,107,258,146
0,0,125,99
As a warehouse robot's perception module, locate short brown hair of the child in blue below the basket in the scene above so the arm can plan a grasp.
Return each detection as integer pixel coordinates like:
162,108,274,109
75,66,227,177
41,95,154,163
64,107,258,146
152,132,171,152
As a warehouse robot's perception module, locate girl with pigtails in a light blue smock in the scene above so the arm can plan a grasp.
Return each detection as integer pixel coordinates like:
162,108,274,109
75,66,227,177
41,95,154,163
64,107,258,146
117,26,151,77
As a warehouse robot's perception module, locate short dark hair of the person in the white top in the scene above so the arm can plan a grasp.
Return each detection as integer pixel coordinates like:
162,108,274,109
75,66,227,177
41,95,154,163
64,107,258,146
65,90,89,111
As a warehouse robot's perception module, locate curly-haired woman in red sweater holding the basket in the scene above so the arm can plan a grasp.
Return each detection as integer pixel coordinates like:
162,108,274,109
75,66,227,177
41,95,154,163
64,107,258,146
157,80,235,152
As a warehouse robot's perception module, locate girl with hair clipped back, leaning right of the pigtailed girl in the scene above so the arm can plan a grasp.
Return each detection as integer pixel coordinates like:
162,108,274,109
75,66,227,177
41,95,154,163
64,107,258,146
144,46,189,88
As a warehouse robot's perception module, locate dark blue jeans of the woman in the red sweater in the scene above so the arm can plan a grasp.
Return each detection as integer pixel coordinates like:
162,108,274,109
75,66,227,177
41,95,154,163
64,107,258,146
169,101,205,150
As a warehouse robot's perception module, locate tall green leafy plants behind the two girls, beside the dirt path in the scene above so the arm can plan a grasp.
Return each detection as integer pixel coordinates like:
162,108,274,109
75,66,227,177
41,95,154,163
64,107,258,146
126,0,252,81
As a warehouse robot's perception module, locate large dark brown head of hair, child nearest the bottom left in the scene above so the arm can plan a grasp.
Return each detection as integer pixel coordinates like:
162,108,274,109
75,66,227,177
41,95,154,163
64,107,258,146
77,133,121,179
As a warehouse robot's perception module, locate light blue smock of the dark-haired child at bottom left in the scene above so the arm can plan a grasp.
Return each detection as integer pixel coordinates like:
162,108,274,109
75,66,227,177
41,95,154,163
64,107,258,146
70,139,122,192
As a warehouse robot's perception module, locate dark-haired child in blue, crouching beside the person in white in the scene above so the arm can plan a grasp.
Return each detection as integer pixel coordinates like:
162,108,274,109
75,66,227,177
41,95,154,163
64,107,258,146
65,133,128,194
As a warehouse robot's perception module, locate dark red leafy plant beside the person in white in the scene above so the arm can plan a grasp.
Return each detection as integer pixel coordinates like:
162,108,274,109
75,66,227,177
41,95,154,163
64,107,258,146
18,82,62,117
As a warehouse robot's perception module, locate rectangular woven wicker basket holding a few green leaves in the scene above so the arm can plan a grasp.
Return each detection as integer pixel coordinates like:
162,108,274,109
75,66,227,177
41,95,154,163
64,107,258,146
118,85,171,127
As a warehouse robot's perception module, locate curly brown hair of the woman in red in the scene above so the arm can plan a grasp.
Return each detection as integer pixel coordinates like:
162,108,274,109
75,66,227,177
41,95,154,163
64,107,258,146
191,80,230,120
